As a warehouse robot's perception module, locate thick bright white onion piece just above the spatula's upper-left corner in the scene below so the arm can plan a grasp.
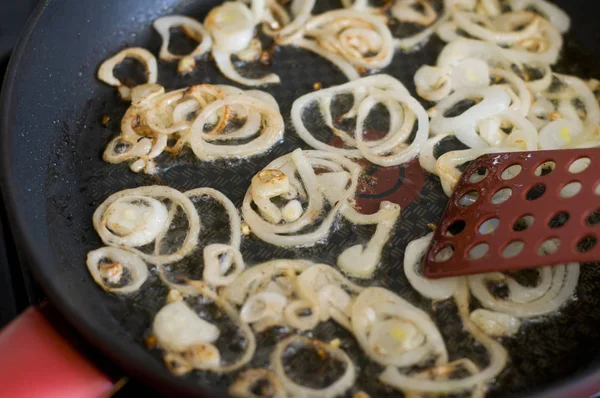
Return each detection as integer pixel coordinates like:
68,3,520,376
431,86,510,148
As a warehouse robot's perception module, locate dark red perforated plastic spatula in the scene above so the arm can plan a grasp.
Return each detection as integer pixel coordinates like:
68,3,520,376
423,148,600,278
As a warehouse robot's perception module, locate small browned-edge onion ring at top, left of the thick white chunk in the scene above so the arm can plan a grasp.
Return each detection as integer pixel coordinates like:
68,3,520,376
152,15,212,61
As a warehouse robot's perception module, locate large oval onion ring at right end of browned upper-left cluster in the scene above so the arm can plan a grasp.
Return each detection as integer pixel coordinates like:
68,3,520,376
189,95,285,160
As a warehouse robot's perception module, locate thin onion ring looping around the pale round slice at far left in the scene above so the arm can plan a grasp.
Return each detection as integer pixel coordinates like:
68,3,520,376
93,185,200,265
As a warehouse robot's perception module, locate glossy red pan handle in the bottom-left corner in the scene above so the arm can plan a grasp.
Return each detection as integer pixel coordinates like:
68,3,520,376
0,307,114,398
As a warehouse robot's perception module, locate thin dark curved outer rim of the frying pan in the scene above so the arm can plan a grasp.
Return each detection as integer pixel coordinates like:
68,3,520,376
0,0,600,398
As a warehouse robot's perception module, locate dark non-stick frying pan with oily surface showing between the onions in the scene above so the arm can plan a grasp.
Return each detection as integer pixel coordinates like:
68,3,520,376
0,0,600,397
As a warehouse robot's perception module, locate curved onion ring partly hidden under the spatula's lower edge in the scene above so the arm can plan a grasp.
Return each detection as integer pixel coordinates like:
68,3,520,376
468,263,579,318
